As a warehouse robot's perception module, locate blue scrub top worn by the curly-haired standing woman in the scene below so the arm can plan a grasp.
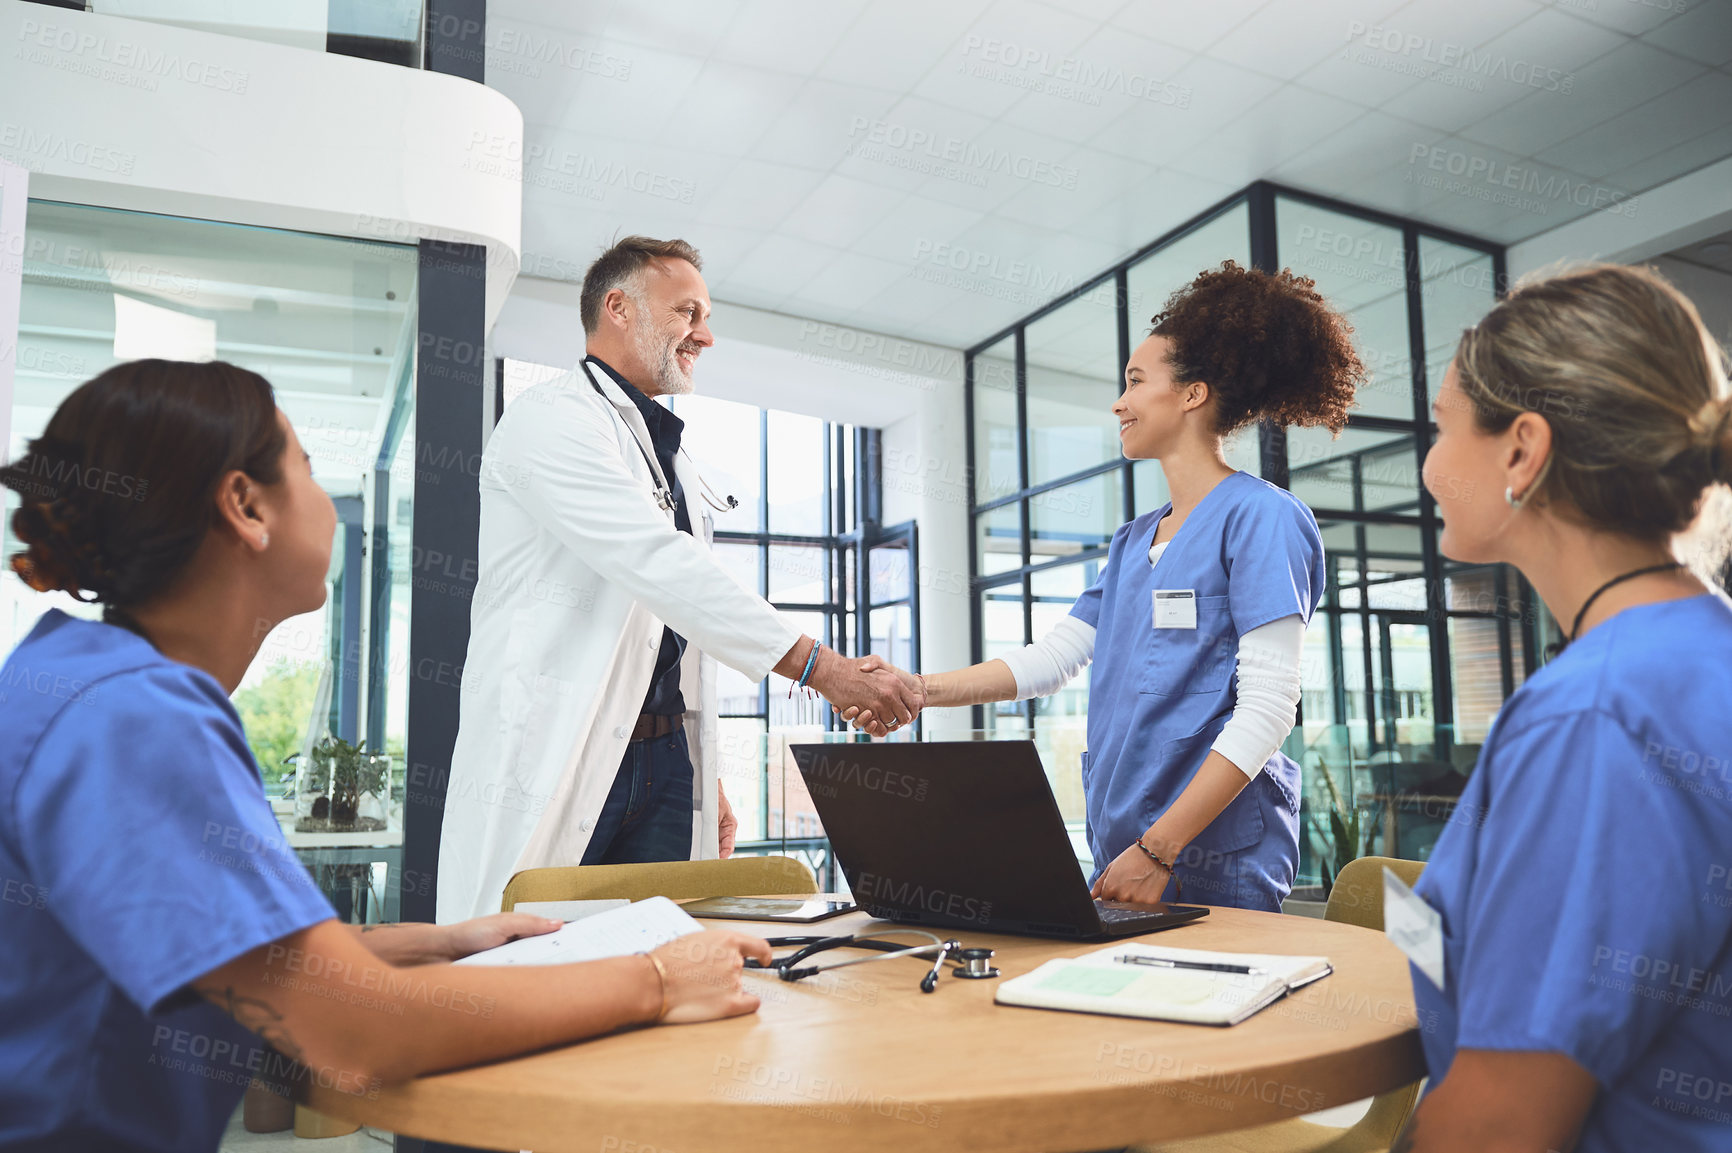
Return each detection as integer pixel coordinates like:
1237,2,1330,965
1070,473,1323,886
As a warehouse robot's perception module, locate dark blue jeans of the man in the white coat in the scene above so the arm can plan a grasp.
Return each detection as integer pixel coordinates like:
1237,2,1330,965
584,724,693,864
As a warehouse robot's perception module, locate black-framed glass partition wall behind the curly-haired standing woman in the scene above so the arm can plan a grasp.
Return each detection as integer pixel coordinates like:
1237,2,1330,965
966,182,1554,885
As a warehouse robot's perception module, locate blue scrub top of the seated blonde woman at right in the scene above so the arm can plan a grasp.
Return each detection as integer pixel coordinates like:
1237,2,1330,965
1413,594,1732,1153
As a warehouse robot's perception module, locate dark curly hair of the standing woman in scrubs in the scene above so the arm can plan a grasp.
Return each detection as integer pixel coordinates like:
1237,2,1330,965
1148,260,1365,436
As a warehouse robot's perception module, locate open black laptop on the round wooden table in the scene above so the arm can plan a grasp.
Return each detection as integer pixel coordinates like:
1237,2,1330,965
790,741,1209,940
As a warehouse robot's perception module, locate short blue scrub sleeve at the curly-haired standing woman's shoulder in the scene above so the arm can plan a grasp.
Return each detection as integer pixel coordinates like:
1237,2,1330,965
1223,490,1323,637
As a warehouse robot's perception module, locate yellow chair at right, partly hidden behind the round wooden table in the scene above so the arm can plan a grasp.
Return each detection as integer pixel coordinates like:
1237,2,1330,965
1128,857,1425,1153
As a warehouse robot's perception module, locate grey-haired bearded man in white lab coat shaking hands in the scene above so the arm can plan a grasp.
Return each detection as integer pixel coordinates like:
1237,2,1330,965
436,237,921,923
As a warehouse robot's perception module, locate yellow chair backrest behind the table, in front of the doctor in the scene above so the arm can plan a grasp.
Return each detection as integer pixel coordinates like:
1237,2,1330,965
499,857,818,912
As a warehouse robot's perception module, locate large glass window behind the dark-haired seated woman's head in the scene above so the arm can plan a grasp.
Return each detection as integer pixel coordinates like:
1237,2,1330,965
0,201,417,803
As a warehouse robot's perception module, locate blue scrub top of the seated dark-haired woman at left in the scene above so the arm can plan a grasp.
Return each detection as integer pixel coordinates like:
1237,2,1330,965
0,611,334,1153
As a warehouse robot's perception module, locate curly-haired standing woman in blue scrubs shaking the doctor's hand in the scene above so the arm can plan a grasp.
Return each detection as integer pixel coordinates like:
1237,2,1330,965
843,261,1365,911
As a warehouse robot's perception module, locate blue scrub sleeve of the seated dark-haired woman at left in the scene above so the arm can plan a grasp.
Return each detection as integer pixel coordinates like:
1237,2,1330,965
14,665,336,1013
